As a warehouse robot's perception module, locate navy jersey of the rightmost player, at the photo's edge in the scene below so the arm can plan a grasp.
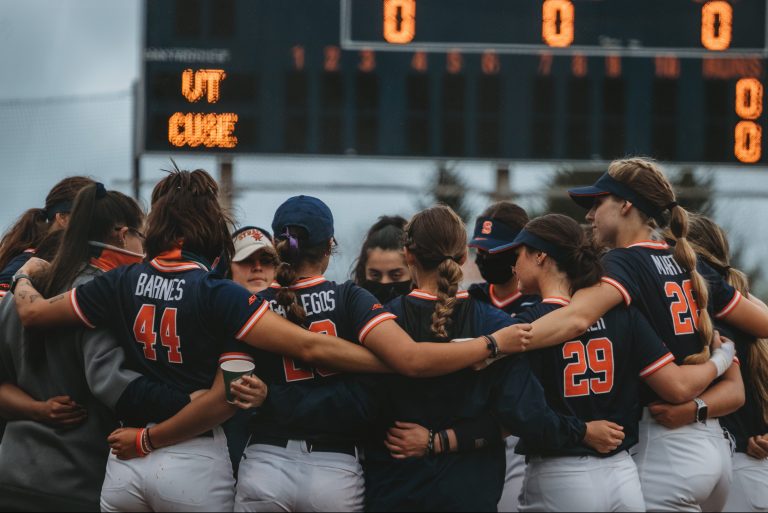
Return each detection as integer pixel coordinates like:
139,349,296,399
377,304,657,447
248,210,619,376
718,327,768,453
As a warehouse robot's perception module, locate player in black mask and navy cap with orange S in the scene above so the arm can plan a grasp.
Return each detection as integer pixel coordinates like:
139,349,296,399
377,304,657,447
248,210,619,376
468,201,541,511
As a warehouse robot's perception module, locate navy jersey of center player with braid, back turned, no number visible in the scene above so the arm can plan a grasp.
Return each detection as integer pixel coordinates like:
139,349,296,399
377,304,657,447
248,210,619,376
365,290,584,511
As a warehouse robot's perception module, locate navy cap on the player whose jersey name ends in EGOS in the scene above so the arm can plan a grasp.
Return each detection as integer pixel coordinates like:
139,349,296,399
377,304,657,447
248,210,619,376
272,195,333,246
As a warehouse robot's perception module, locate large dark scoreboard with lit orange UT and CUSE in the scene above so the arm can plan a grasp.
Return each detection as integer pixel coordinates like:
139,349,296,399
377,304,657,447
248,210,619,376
140,0,768,165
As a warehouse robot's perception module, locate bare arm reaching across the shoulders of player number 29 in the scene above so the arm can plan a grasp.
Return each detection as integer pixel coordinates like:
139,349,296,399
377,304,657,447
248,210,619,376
529,283,623,350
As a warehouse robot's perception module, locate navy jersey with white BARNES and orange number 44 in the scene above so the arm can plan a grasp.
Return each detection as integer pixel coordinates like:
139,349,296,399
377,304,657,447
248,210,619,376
70,250,269,393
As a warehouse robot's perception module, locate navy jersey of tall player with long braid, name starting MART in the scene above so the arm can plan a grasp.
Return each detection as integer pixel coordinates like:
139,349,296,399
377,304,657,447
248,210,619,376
603,241,741,364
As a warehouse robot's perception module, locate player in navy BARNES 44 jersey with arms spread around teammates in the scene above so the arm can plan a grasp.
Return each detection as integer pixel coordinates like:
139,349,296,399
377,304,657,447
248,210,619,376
14,170,402,511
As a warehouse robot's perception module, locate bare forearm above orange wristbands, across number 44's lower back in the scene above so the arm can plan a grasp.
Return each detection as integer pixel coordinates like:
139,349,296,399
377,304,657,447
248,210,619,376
151,372,236,449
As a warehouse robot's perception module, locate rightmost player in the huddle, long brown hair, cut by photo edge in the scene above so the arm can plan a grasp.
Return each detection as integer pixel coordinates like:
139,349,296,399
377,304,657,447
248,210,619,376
688,215,768,511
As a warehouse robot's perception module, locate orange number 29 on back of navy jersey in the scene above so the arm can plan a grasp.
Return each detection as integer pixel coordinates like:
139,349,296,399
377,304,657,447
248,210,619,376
563,338,613,398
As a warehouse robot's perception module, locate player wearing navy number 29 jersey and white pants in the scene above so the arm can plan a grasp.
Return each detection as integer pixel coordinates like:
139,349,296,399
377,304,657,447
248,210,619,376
513,214,735,511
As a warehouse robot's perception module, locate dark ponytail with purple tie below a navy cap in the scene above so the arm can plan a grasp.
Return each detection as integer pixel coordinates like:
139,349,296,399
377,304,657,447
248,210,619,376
275,226,332,326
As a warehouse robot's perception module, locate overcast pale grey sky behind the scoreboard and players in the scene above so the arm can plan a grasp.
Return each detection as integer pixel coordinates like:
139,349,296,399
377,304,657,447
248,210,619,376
0,0,768,288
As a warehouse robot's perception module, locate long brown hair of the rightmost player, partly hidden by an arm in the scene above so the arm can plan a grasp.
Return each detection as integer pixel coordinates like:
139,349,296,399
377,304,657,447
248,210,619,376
689,214,768,424
